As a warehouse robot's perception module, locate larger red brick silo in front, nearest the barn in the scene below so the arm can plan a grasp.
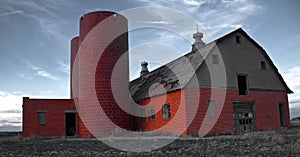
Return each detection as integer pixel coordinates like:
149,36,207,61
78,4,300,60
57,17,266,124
73,11,130,137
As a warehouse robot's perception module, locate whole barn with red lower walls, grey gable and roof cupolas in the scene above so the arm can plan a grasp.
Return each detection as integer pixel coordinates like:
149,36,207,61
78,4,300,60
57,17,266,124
130,28,292,135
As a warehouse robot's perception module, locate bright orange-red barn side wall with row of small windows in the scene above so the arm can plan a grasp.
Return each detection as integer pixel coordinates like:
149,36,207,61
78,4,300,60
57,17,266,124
135,90,186,134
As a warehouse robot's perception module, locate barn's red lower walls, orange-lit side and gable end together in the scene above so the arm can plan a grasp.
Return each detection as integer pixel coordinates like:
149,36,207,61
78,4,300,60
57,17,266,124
135,88,290,135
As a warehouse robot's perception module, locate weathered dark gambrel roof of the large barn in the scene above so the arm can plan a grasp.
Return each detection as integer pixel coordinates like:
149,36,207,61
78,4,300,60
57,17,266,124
129,28,292,101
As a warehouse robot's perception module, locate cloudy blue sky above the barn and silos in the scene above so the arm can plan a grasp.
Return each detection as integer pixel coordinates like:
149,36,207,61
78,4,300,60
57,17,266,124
0,0,300,131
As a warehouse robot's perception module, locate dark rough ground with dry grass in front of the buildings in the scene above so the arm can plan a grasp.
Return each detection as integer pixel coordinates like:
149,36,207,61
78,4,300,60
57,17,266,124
0,128,300,157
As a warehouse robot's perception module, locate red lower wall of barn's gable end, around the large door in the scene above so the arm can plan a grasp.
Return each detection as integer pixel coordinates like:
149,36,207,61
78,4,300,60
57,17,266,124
185,88,290,134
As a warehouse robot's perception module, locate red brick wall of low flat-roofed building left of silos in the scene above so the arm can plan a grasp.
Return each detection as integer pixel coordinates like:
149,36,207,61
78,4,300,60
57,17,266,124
23,97,78,137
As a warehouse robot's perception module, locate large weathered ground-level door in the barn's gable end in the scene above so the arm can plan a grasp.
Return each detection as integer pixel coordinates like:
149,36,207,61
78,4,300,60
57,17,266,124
233,102,255,133
